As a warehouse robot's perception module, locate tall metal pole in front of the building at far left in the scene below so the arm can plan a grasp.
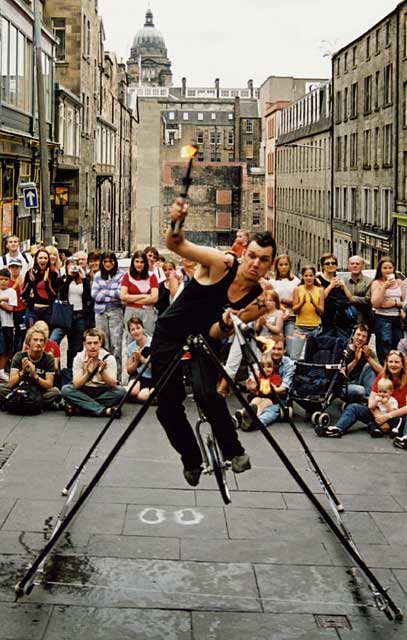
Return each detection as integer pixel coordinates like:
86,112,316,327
34,0,52,245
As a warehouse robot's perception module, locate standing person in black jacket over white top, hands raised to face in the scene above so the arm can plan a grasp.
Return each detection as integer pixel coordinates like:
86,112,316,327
51,256,91,369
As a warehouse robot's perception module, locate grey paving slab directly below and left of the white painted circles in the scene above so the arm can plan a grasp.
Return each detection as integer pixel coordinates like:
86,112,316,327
86,535,180,560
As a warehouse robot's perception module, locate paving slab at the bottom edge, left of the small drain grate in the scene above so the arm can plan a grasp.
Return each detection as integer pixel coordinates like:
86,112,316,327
192,611,338,640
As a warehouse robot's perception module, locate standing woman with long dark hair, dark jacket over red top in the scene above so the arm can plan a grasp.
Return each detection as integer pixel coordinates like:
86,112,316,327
21,249,59,329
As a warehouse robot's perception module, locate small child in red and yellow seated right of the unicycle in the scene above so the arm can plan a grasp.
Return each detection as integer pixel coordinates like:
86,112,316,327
235,353,282,431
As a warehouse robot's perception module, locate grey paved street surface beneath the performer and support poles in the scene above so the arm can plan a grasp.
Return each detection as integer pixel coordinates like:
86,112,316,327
0,400,407,640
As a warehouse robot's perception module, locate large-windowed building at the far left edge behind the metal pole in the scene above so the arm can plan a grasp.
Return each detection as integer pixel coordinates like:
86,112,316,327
0,0,57,252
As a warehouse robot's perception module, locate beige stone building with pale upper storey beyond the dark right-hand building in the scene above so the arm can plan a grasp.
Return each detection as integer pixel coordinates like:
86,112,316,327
275,82,331,271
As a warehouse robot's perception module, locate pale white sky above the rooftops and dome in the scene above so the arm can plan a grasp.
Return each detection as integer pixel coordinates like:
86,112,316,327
98,0,397,87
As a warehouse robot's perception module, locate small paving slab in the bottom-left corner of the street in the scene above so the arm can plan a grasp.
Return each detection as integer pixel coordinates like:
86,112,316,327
0,603,52,640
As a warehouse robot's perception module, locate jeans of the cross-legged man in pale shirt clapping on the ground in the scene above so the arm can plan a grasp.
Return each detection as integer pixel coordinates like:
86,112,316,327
61,384,127,416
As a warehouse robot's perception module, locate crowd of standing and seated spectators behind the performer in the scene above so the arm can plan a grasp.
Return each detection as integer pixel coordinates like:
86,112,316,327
0,229,407,449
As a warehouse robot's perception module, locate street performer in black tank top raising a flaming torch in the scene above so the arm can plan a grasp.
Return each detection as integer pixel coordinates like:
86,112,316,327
151,197,276,486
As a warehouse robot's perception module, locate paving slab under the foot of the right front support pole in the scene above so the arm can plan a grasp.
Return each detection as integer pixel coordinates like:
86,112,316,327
255,565,407,616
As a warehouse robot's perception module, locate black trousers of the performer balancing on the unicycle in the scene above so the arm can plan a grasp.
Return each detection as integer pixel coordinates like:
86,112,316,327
151,338,244,469
